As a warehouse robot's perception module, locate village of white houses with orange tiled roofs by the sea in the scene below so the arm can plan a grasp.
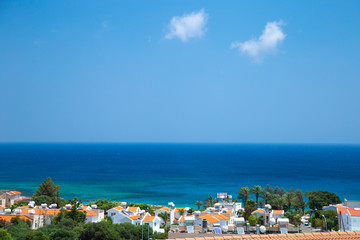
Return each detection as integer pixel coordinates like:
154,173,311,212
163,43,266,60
0,184,360,239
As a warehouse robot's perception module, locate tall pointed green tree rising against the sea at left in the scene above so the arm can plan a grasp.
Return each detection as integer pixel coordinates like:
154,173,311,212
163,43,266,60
33,177,64,207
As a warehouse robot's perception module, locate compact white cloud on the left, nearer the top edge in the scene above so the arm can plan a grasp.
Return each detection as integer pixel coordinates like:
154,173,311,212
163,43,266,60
165,9,208,42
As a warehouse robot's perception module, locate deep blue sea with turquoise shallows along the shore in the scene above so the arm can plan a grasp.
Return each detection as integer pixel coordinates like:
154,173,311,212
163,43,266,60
0,143,360,206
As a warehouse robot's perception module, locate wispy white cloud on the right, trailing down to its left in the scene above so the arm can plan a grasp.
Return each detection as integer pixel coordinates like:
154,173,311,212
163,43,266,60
231,21,286,61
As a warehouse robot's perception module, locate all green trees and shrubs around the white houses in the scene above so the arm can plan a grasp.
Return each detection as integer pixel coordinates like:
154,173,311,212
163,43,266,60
0,178,341,240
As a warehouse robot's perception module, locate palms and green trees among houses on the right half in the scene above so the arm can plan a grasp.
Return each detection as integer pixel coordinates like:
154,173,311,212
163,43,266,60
194,184,341,230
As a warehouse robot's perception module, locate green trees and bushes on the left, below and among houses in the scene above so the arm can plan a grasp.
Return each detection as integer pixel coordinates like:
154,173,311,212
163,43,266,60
0,178,168,240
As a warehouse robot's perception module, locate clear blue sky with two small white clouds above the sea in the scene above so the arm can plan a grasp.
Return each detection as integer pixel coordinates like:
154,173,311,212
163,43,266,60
0,0,360,144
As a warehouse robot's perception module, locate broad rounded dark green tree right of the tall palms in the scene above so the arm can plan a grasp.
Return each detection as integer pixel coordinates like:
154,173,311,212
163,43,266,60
305,191,341,209
